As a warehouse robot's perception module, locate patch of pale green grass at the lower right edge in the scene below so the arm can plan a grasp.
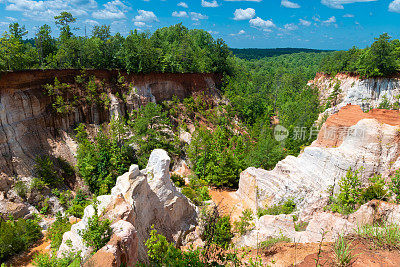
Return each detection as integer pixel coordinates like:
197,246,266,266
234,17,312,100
357,223,400,250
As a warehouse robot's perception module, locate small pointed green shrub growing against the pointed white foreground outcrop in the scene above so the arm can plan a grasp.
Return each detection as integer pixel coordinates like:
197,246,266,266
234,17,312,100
79,204,112,251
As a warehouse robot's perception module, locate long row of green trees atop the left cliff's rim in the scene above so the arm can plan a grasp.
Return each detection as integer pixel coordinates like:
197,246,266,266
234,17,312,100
0,12,230,73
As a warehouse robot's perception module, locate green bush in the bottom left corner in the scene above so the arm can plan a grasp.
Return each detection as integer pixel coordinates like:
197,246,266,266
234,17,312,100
0,218,42,262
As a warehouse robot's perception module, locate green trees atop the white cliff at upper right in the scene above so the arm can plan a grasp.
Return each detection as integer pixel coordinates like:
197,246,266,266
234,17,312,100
320,33,400,77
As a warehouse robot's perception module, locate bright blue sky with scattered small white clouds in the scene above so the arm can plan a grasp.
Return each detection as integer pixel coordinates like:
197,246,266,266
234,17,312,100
0,0,400,49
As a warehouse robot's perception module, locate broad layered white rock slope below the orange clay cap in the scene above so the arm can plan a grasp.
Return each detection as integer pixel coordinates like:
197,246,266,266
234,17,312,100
236,109,400,220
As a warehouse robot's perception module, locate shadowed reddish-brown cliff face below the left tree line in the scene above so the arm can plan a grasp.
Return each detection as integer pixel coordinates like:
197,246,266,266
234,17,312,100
0,70,221,177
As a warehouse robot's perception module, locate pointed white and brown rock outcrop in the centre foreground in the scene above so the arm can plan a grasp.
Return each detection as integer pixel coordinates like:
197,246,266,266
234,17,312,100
57,149,197,266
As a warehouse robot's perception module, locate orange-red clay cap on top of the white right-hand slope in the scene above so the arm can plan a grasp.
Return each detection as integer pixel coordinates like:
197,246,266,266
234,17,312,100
313,105,400,147
